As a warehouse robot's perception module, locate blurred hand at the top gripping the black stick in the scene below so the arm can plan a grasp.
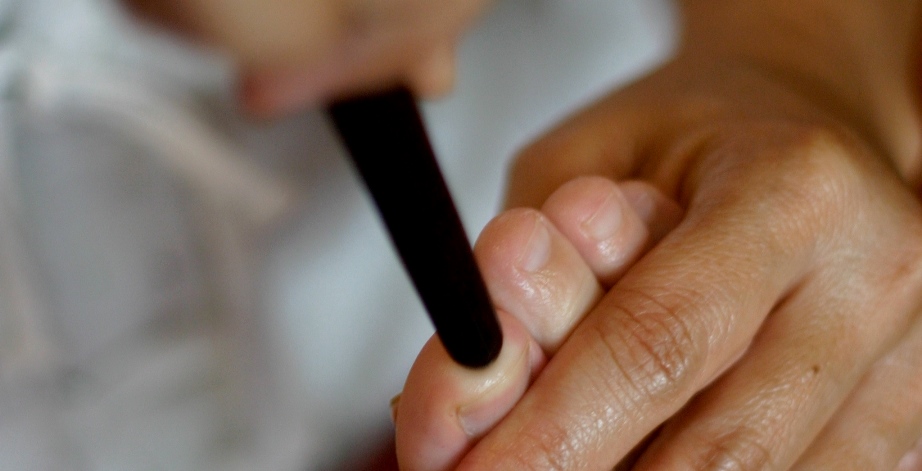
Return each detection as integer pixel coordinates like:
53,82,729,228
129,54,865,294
125,0,487,114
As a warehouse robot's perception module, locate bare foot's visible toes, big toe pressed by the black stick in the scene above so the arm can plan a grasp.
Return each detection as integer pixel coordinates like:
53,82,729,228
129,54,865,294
395,177,681,470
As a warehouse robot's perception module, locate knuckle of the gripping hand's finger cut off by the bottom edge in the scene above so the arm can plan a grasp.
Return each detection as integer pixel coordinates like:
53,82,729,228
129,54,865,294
694,427,775,471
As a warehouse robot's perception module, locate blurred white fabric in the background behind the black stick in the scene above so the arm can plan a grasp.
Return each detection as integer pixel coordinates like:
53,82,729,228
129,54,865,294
0,0,674,471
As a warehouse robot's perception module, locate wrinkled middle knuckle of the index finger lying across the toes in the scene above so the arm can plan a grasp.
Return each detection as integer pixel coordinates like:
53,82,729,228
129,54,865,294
595,291,707,404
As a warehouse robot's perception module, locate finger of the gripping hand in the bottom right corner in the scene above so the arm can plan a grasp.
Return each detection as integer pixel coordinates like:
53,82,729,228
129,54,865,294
793,314,922,471
